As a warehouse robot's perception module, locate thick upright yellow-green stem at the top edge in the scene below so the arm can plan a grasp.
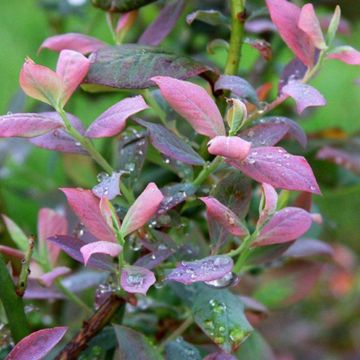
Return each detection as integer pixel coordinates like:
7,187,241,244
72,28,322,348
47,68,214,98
225,0,246,75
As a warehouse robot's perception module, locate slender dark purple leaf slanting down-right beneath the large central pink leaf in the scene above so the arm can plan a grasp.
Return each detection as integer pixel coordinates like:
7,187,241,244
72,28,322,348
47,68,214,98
136,120,205,165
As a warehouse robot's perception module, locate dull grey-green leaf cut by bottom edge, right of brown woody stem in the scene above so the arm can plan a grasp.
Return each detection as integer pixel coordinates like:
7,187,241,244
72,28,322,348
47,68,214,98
114,325,163,360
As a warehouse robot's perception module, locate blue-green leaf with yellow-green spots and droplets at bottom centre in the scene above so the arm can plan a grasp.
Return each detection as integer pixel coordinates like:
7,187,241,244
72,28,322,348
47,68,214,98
192,286,253,352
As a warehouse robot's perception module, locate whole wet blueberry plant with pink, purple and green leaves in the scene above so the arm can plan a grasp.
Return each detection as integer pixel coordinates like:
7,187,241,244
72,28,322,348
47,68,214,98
0,0,360,360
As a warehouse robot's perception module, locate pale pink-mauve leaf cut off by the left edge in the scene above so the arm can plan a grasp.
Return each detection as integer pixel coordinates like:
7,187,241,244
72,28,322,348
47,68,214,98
0,113,63,138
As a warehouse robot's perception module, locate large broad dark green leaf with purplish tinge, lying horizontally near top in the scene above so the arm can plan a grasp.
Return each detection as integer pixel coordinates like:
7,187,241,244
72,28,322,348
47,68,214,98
83,44,211,91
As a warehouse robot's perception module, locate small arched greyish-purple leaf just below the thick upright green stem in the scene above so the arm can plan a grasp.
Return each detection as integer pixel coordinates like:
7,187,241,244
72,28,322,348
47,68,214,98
214,75,259,105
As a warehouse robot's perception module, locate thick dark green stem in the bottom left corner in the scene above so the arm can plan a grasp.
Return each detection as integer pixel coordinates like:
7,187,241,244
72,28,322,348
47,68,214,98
0,255,30,343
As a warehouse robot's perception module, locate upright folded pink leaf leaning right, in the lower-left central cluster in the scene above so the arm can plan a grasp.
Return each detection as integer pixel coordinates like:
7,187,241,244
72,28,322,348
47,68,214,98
121,183,164,236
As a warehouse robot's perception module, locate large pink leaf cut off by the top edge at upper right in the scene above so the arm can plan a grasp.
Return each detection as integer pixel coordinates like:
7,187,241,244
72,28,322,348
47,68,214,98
266,0,315,67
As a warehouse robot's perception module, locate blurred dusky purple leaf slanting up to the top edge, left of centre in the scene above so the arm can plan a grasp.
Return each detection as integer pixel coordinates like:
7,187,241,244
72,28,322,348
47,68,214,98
138,0,185,46
